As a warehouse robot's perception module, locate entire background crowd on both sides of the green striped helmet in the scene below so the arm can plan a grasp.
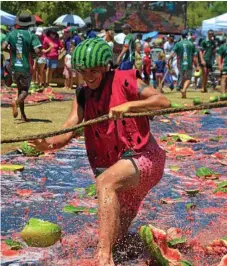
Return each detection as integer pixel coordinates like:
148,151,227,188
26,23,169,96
1,13,227,121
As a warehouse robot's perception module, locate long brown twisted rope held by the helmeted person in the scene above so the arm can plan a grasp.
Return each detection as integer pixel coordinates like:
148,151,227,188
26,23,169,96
1,101,227,144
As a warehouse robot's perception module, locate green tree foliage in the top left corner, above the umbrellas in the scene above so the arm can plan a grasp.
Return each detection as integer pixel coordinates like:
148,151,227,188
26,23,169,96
1,1,92,25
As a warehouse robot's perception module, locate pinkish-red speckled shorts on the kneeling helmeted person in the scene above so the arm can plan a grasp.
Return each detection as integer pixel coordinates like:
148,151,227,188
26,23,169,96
118,143,166,213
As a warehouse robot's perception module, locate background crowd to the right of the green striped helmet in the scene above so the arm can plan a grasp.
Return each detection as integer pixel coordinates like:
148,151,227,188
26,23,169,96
113,25,227,98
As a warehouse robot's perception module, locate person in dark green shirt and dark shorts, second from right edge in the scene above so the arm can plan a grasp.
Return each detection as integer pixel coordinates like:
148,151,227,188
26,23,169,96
200,30,216,92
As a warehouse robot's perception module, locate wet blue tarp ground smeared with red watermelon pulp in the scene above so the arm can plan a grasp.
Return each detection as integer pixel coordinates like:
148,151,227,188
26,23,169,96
1,108,227,266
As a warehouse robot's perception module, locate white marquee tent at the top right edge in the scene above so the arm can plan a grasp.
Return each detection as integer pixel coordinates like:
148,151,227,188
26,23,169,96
202,13,227,34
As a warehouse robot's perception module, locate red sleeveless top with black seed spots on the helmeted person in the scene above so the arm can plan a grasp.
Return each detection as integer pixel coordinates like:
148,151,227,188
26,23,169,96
84,70,150,169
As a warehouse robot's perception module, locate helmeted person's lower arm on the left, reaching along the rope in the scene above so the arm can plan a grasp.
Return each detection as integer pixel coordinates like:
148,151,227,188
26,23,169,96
30,97,84,151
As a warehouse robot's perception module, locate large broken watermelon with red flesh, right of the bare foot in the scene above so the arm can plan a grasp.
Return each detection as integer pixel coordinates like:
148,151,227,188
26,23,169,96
139,225,181,266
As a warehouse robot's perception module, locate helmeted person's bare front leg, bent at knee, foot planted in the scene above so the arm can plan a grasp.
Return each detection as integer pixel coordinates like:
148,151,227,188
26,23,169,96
97,160,139,266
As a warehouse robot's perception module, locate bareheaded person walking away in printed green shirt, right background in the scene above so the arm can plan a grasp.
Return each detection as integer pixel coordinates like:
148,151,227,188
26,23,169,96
168,30,199,98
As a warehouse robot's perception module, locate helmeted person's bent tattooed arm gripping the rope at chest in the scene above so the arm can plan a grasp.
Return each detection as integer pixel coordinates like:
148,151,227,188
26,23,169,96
109,79,171,118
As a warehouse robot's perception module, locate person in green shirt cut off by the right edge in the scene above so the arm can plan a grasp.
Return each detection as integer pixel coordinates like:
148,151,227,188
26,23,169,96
217,39,227,93
